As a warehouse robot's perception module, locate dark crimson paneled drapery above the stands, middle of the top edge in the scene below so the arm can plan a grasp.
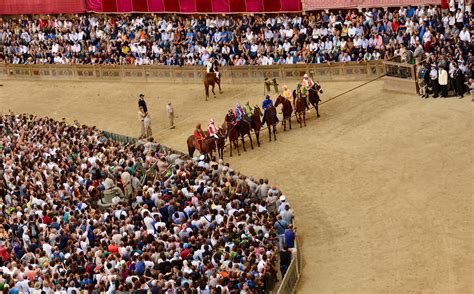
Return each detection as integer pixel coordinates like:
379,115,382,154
85,0,301,13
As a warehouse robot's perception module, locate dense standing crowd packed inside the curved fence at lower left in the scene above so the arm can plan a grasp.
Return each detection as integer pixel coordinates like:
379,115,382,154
0,113,295,294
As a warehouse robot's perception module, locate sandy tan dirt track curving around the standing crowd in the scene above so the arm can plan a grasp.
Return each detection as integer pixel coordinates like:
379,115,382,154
0,81,474,293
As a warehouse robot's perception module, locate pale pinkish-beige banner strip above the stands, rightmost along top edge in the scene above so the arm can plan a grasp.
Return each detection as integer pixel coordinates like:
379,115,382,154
301,0,441,11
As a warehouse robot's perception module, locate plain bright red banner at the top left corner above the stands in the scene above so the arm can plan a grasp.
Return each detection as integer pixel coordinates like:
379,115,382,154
0,0,86,15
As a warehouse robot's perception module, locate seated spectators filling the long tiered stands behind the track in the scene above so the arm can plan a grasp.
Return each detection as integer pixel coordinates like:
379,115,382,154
0,1,472,66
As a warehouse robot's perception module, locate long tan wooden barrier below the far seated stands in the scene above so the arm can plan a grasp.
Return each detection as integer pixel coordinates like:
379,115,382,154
0,61,384,83
